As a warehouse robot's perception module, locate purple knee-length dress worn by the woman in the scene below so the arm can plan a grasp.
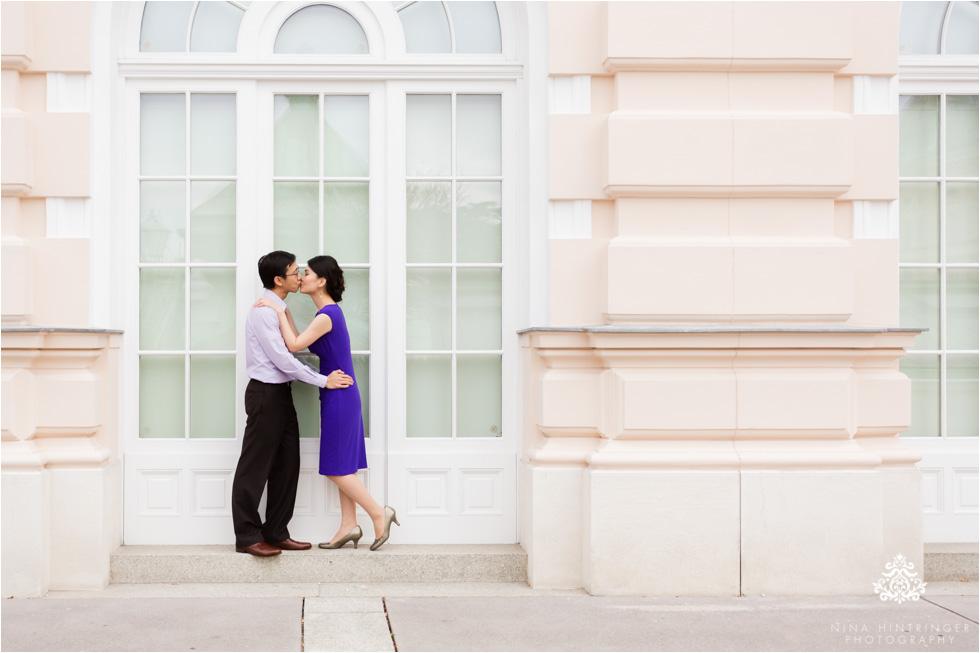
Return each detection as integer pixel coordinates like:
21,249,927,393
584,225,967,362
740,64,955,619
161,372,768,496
310,304,367,476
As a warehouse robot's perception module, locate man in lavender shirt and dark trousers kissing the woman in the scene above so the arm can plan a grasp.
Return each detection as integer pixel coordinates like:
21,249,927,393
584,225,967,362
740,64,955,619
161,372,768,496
231,251,353,556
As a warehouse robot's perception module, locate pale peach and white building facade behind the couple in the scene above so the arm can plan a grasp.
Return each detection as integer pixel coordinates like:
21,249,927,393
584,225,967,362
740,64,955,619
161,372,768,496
2,1,978,596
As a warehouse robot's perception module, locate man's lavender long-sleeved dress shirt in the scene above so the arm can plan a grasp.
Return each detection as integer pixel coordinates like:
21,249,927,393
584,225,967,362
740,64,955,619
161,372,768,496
245,289,327,388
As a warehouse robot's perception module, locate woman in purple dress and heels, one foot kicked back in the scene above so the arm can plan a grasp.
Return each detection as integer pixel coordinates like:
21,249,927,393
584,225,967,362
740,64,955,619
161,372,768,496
255,256,401,551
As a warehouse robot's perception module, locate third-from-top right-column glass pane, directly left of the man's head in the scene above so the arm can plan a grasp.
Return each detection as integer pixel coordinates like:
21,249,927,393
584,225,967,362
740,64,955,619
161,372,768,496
191,268,236,351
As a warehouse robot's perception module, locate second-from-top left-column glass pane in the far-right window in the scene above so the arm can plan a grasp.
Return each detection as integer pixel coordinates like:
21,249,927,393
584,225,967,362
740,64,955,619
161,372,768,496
898,181,939,263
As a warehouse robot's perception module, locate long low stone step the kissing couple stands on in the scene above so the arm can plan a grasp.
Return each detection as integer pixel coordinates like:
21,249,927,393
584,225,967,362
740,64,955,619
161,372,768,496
110,544,527,583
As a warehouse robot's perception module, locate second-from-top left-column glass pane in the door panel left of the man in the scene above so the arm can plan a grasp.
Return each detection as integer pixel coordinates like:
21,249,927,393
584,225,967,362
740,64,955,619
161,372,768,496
140,181,187,263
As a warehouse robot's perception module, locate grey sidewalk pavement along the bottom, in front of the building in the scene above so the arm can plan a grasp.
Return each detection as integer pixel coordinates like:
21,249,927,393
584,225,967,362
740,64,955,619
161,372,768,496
0,581,978,651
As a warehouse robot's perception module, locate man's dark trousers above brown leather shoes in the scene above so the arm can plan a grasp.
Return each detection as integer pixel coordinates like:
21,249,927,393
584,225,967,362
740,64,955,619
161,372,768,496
231,379,299,546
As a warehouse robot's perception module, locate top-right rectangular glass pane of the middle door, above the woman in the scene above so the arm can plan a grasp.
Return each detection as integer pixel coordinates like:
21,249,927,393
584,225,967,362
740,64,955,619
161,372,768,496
323,95,368,177
